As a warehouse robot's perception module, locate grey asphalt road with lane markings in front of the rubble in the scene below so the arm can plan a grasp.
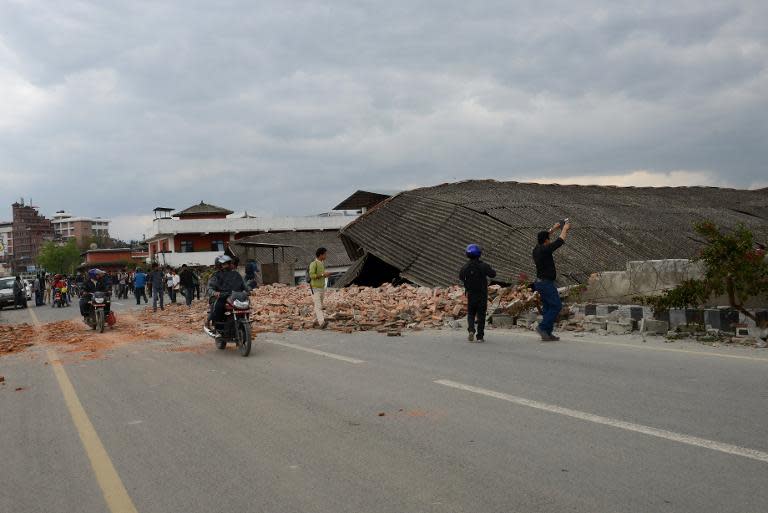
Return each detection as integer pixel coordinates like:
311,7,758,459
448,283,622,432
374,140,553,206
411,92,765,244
0,306,768,513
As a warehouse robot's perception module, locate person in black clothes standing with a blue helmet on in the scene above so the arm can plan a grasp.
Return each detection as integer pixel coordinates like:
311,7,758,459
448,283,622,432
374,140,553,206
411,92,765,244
459,244,496,342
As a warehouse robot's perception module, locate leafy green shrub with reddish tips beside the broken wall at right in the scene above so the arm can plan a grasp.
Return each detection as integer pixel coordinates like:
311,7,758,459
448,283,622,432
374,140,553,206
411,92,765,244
641,221,768,320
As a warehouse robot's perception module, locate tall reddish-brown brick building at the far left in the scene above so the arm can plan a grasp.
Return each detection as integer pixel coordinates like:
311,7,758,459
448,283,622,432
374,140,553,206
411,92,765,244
11,200,53,272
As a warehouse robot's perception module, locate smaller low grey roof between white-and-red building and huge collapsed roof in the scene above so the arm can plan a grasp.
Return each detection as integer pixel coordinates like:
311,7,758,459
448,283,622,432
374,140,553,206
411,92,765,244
231,230,352,269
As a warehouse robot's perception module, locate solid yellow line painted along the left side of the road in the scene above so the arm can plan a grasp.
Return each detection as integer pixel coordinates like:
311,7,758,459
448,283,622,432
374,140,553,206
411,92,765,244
29,310,137,513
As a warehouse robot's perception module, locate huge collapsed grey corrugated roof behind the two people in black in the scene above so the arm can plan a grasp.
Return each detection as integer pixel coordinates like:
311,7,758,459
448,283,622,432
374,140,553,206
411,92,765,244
340,180,768,286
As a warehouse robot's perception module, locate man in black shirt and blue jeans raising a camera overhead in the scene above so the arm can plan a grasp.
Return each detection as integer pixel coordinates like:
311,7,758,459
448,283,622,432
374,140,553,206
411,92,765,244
532,219,571,342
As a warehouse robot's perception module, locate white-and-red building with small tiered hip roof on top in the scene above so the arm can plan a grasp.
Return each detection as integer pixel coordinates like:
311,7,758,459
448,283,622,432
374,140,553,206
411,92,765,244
146,202,357,267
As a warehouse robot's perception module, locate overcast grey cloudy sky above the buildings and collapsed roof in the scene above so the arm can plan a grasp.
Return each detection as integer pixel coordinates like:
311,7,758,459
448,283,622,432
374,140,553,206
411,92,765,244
0,0,768,239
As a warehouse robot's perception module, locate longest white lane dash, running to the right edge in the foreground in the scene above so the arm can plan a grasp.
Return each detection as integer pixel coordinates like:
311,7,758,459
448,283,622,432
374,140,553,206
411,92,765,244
435,379,768,463
